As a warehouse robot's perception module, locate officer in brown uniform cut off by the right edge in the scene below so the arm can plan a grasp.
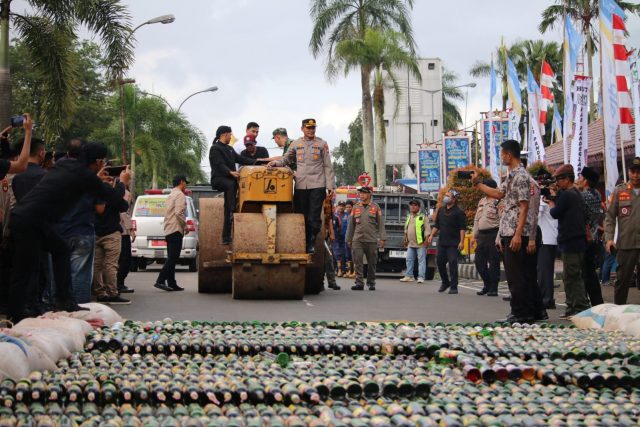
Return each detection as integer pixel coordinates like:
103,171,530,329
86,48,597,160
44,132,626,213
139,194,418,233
604,157,640,304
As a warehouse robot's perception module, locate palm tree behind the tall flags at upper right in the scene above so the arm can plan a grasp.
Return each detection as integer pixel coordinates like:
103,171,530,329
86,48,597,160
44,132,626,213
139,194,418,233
538,0,640,120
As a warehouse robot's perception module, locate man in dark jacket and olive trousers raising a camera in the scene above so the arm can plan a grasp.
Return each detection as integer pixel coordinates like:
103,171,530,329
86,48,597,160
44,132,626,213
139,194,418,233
545,164,589,319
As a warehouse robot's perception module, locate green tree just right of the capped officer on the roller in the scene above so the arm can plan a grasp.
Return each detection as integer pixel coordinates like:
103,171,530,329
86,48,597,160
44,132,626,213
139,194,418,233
331,111,365,185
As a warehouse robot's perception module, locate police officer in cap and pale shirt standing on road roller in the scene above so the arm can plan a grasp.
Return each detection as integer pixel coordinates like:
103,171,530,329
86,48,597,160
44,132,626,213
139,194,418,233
268,119,336,253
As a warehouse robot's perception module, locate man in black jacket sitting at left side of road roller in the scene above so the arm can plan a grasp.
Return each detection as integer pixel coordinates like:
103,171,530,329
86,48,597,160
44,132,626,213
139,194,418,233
209,126,256,245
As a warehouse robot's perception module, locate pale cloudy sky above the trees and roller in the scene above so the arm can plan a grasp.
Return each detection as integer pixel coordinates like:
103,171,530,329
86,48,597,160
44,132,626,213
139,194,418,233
76,0,640,169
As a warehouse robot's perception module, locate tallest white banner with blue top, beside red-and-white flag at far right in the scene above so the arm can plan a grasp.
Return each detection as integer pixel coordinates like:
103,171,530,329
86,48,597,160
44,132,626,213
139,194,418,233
598,0,624,196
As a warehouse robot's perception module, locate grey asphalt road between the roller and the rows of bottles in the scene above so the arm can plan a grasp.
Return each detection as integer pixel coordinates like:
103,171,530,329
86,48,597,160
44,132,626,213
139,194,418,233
113,264,576,322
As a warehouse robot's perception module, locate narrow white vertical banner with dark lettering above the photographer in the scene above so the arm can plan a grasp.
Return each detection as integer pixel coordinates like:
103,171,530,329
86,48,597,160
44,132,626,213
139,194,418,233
571,77,591,174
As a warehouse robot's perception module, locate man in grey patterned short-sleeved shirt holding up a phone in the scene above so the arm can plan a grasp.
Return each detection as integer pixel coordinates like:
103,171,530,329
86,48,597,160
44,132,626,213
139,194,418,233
472,139,536,323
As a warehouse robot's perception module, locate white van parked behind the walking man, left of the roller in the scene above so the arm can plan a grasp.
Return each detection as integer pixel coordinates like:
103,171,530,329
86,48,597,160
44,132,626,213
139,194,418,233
131,189,198,271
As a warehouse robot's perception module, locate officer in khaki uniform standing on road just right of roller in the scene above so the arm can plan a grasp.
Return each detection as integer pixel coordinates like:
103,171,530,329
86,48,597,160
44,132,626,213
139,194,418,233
346,187,387,291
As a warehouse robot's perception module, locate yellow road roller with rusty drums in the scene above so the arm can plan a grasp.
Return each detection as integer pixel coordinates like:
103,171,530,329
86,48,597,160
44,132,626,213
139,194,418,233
198,166,325,299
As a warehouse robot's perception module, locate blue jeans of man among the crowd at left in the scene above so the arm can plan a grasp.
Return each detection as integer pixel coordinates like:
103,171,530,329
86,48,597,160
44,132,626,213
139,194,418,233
67,234,96,304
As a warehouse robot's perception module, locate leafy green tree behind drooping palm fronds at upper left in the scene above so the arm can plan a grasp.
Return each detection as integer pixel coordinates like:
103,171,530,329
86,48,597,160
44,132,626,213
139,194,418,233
10,40,116,149
